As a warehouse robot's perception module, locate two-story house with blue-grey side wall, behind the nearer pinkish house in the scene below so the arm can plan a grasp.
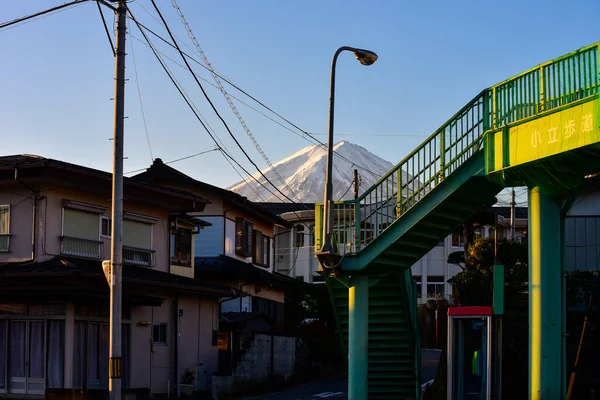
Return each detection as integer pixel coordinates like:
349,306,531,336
134,159,291,331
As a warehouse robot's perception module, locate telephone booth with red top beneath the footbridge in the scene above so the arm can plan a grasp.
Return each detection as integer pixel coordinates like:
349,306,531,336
447,307,502,400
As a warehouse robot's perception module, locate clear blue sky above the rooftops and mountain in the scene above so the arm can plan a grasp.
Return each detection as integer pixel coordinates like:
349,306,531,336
0,0,600,203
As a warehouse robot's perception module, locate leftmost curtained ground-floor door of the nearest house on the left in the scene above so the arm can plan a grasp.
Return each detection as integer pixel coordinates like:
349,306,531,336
8,320,46,394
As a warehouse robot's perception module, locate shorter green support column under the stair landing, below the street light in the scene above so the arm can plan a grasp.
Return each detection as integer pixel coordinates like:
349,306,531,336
348,276,369,400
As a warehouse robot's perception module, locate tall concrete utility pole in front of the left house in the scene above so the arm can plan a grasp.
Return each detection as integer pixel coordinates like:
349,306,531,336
108,0,127,400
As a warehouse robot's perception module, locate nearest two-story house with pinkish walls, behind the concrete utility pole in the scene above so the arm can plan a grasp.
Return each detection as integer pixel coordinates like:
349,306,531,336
0,155,238,396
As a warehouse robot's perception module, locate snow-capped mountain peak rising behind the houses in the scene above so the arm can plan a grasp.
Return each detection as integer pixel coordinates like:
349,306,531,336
228,141,394,203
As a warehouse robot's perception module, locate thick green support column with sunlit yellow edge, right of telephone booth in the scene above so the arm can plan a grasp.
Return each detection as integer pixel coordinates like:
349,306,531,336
529,187,564,400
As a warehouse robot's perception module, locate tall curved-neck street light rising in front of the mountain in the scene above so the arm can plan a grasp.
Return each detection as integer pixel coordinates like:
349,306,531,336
320,46,377,256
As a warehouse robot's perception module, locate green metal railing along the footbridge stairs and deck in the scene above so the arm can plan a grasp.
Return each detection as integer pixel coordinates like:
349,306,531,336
316,42,600,255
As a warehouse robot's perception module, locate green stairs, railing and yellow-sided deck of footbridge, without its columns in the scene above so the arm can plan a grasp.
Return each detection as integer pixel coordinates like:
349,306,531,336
315,43,600,400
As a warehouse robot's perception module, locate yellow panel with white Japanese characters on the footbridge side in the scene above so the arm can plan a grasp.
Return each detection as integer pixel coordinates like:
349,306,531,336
509,99,600,166
